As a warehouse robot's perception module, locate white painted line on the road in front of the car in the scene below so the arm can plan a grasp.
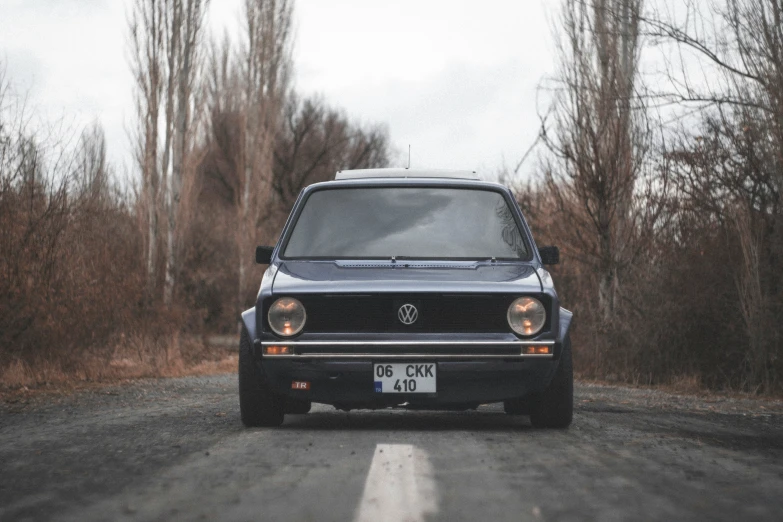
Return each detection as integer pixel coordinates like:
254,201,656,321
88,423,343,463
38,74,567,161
354,444,438,522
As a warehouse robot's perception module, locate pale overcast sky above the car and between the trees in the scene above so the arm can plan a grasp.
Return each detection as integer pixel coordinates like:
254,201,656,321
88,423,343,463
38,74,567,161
0,0,558,177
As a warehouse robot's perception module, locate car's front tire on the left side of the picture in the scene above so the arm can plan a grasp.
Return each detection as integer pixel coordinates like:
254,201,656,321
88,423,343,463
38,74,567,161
239,325,283,428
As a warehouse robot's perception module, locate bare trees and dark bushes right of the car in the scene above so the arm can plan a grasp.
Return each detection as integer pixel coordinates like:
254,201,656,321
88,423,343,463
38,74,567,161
518,0,783,393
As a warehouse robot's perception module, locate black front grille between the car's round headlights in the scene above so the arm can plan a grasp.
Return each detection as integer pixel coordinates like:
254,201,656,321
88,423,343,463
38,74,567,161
264,295,549,333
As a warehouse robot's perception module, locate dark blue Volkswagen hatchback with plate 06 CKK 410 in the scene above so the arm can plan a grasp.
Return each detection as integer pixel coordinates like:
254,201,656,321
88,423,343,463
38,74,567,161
239,169,573,428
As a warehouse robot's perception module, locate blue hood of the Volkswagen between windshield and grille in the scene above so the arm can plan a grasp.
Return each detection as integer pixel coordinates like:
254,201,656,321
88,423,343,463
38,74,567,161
272,261,542,294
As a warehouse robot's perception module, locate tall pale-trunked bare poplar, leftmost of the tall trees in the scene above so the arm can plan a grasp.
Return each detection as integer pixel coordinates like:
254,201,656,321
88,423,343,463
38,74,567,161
129,0,209,306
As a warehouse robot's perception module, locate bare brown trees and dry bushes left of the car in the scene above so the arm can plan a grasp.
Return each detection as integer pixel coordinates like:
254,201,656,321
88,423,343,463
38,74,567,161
0,0,390,385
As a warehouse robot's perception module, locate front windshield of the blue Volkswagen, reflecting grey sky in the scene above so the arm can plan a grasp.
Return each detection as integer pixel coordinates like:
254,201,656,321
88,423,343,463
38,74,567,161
283,187,529,259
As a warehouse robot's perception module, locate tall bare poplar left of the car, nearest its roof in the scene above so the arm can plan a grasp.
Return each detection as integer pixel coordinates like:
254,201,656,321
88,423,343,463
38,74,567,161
204,0,293,316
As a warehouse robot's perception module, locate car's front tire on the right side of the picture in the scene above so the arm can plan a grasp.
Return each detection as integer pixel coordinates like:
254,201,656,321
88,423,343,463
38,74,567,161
530,337,574,429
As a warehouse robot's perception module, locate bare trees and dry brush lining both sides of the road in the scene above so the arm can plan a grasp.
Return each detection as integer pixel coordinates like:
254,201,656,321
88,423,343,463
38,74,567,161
0,0,783,394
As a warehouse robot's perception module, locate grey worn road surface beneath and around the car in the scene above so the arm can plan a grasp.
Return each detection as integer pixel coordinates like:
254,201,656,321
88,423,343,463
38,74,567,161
0,375,783,522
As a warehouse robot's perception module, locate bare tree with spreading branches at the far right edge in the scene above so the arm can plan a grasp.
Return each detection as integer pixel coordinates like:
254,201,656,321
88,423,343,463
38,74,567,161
645,0,783,391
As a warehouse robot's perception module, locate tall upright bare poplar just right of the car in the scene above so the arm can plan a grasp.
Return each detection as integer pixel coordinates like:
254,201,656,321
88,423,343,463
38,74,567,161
544,0,656,323
